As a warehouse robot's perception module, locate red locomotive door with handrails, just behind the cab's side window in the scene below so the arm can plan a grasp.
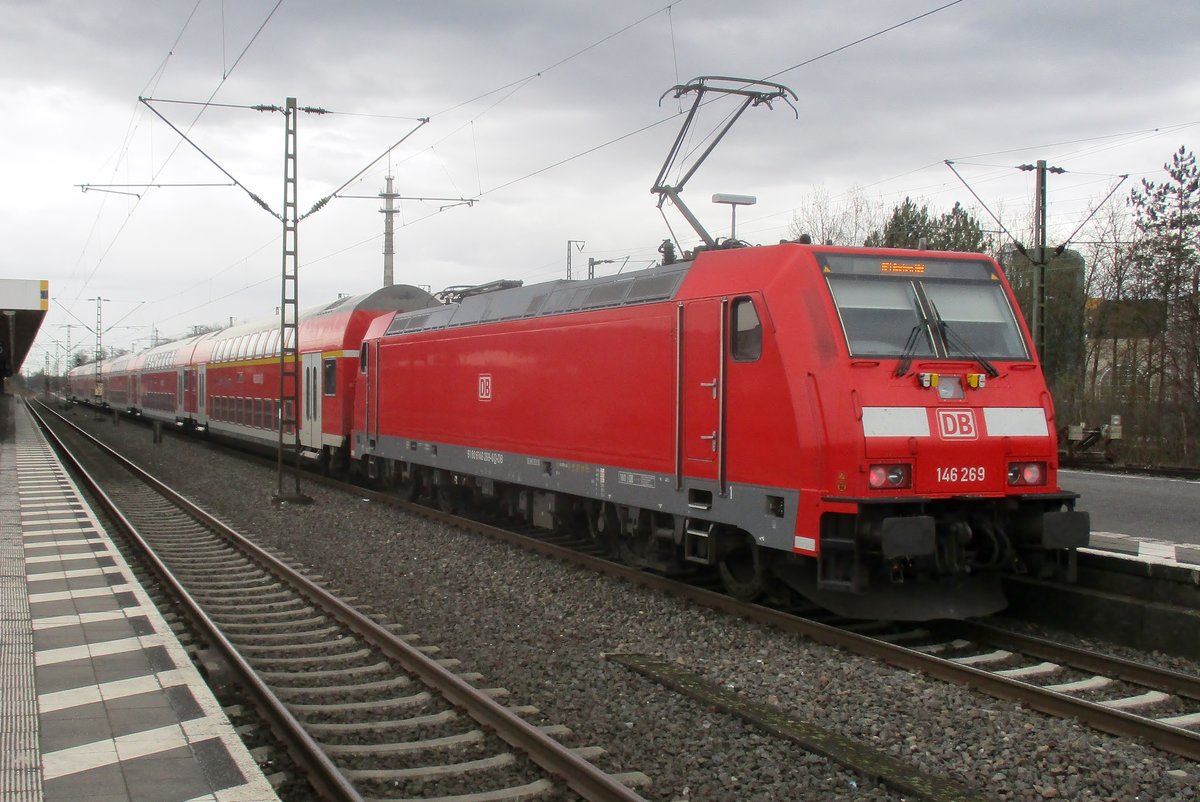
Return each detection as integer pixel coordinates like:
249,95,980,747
676,300,728,495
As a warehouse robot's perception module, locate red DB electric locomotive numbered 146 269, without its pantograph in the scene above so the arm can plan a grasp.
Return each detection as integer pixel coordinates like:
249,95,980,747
353,244,1088,620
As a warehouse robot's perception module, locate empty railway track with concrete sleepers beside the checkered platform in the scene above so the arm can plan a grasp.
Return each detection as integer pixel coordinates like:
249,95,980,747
34,409,648,802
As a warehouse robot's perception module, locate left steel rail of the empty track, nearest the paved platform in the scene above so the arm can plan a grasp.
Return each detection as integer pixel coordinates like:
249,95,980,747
29,405,362,802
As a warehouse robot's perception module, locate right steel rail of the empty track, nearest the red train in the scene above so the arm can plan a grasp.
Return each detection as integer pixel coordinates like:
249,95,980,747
32,398,647,802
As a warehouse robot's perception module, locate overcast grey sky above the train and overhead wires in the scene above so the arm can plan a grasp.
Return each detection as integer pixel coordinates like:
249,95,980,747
0,0,1200,370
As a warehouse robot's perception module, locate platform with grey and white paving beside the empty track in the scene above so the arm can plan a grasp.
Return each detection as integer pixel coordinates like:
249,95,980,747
0,395,278,802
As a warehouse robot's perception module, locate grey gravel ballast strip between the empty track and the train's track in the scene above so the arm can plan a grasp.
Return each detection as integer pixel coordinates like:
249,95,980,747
63,411,1200,802
